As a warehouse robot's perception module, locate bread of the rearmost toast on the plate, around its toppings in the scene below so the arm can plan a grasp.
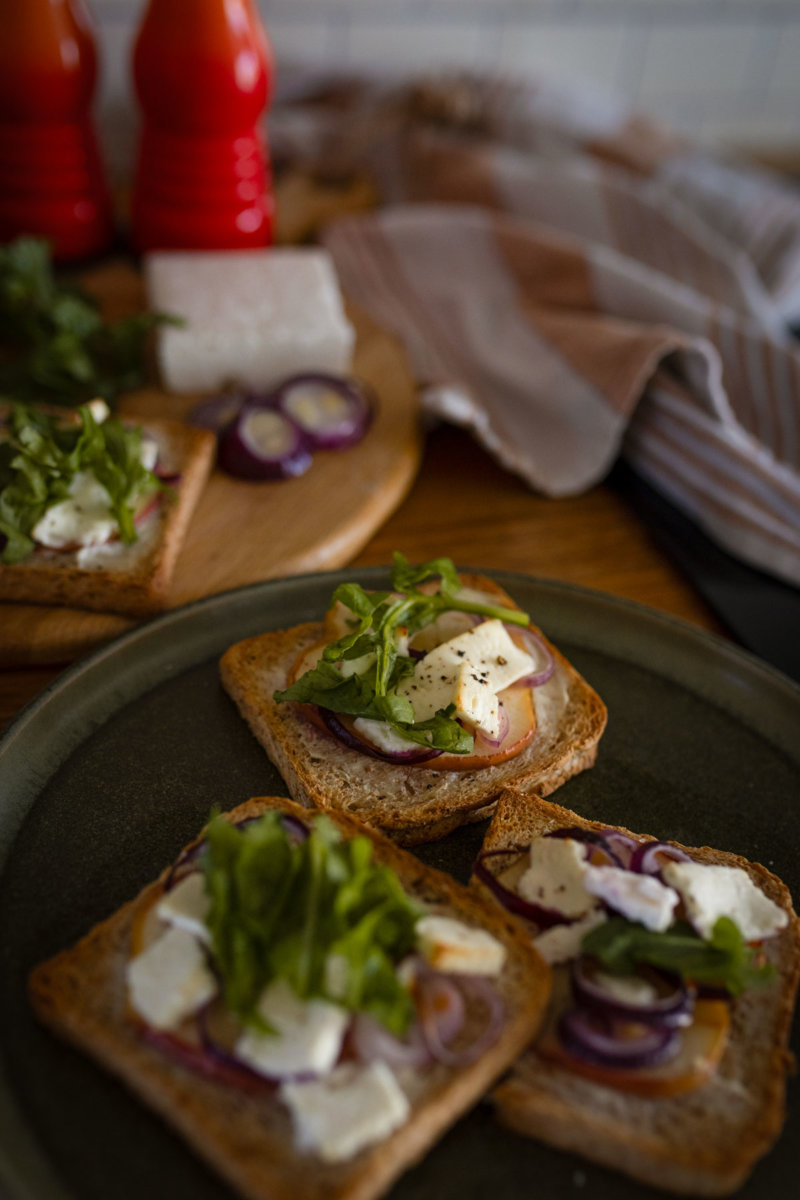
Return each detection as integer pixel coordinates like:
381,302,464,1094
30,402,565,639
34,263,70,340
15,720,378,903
221,575,607,846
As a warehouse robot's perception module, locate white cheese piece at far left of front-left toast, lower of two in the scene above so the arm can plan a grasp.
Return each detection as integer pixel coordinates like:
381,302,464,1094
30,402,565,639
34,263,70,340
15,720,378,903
127,926,217,1030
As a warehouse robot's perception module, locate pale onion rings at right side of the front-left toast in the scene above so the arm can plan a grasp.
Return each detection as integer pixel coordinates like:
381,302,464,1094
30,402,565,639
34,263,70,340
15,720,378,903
417,972,505,1067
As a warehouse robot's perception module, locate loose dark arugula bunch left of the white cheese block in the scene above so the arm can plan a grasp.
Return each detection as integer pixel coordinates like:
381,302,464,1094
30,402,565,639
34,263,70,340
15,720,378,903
0,238,180,404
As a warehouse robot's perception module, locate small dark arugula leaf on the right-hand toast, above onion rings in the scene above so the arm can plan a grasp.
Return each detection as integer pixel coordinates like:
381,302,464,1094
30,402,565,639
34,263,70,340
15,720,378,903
582,917,775,996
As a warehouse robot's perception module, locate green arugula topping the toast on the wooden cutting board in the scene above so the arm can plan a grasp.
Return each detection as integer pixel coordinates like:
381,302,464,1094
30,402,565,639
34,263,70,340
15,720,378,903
0,404,167,563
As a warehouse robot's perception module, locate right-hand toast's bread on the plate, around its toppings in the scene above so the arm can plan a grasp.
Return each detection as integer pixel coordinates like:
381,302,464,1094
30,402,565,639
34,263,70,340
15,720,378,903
475,790,800,1195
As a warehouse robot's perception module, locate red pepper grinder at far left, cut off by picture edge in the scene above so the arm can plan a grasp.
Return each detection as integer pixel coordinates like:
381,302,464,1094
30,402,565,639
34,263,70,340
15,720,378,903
0,0,112,259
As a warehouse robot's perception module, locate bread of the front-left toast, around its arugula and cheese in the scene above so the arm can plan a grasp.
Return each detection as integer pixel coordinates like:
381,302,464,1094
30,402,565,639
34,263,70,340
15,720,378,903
29,797,549,1200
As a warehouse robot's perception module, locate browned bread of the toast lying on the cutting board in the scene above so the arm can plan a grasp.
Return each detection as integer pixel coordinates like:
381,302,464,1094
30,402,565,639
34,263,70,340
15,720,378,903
0,419,216,617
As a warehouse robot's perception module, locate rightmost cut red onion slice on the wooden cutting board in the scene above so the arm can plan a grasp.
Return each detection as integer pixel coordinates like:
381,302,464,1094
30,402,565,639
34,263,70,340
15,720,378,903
272,372,374,450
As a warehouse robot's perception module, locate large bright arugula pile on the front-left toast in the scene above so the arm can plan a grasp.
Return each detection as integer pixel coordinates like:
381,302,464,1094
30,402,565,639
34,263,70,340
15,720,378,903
203,811,420,1034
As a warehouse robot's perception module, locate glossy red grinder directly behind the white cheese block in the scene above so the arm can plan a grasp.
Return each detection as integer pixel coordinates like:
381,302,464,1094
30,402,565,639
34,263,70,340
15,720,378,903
131,0,273,251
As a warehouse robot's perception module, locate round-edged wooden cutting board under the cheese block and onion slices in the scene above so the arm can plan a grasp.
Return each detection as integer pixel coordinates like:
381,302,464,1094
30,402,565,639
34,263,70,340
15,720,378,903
0,263,421,667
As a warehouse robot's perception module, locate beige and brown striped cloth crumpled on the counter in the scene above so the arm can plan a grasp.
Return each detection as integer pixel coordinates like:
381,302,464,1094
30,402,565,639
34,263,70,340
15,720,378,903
272,70,800,584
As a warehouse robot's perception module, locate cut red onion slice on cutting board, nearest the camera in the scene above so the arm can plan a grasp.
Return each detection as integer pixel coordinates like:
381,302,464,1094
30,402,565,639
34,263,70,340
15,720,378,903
217,404,311,480
